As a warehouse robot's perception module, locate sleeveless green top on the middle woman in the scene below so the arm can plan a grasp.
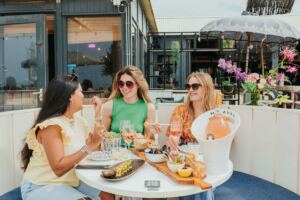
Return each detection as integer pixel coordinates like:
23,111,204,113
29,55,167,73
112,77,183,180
110,97,148,143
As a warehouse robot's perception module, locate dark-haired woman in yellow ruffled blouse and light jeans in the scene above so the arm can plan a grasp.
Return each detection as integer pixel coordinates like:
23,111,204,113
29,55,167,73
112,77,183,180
21,74,114,200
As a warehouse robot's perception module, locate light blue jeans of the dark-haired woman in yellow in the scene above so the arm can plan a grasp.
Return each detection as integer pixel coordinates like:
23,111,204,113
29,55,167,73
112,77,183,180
21,180,100,200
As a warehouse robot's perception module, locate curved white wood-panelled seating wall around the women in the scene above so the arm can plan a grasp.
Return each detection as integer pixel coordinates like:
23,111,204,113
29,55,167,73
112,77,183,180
0,103,300,195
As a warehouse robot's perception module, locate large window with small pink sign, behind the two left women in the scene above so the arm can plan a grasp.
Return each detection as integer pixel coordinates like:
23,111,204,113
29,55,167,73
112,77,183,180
67,17,121,97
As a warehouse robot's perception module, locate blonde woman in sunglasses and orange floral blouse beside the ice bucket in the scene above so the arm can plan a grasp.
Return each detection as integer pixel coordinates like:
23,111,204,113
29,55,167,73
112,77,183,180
167,72,215,149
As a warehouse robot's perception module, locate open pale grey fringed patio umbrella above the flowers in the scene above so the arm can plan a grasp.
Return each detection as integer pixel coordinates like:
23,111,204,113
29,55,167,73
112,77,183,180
200,15,300,73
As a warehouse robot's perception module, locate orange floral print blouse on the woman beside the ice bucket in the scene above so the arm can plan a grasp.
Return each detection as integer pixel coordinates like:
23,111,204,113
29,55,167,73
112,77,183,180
167,104,196,143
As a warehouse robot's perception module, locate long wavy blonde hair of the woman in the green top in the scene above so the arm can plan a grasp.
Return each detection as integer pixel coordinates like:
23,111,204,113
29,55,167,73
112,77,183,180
108,65,152,103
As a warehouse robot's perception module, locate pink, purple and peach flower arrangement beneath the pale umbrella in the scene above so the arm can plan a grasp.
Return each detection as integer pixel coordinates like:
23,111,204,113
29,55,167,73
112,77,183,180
218,48,299,105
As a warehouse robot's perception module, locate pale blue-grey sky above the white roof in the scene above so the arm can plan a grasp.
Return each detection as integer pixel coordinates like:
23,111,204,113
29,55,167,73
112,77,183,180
151,0,300,18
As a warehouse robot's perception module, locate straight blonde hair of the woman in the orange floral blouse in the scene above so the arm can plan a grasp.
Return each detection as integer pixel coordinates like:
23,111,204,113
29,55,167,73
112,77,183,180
185,72,216,118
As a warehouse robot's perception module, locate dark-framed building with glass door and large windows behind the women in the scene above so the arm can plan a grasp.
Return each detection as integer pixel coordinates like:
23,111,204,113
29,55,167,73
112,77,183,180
0,0,157,111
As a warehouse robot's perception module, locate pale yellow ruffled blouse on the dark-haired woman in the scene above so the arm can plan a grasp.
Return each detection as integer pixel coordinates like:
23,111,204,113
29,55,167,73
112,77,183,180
24,113,90,187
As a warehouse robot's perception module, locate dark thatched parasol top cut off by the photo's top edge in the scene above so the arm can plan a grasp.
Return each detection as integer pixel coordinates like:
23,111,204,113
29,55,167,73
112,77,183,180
246,0,295,15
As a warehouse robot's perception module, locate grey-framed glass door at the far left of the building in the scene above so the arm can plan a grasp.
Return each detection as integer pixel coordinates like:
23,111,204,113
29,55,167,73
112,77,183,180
0,15,48,112
